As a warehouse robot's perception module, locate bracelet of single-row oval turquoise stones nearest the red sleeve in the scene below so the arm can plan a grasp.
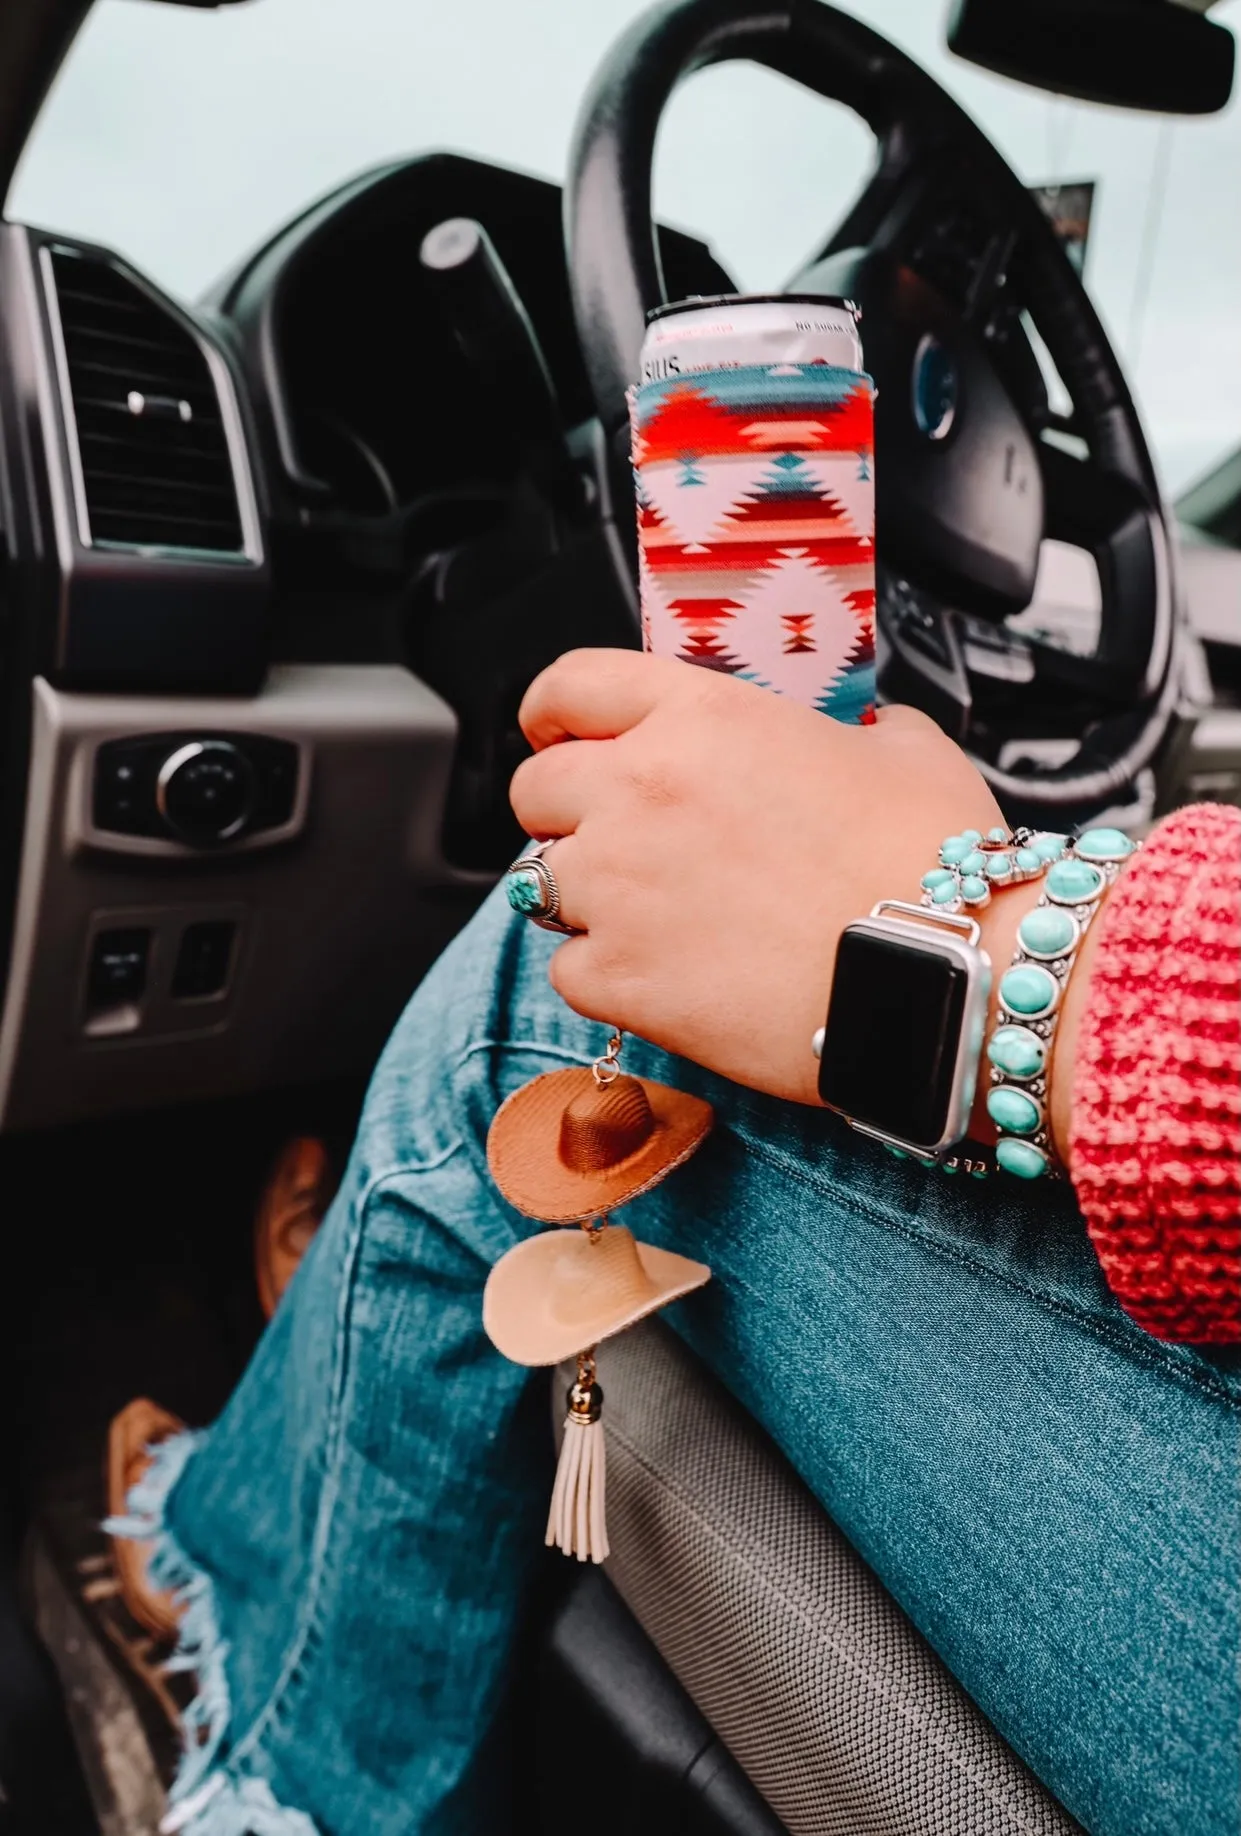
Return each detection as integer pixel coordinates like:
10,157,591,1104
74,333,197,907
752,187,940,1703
986,828,1138,1179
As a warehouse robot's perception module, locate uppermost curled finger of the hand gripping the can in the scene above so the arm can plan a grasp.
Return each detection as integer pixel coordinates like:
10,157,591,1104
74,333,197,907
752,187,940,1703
518,650,687,753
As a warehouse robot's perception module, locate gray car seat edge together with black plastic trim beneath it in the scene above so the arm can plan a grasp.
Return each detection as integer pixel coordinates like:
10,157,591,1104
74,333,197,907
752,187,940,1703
542,1322,1079,1836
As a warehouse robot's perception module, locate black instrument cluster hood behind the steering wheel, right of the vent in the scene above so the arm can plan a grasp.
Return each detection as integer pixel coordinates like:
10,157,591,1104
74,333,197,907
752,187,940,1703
216,152,731,580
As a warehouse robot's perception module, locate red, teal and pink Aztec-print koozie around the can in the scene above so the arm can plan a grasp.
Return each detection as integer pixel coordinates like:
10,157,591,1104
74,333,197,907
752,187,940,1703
630,362,876,723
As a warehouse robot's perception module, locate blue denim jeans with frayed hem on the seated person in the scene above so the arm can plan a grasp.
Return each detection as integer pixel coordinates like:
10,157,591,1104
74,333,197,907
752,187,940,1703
123,873,1241,1836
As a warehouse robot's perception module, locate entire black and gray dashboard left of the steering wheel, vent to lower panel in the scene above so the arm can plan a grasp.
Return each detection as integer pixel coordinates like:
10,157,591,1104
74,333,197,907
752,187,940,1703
0,154,729,1129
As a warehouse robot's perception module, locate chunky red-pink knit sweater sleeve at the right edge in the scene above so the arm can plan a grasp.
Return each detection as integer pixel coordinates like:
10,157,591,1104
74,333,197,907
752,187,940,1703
1070,804,1241,1344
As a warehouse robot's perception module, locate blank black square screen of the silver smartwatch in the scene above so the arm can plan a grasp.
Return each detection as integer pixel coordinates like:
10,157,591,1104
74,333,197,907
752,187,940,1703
819,925,969,1148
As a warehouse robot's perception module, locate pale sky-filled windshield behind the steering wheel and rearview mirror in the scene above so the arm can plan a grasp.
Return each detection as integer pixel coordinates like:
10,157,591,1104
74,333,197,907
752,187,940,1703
7,0,1241,492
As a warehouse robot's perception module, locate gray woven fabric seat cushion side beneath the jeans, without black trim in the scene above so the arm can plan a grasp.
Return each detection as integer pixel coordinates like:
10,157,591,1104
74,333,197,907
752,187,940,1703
556,1322,1079,1836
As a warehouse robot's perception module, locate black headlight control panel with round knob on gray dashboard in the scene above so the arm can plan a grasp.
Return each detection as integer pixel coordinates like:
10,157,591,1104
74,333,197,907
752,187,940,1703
92,733,299,848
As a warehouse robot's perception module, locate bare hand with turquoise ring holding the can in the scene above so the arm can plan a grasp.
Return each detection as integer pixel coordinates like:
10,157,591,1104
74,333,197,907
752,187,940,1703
510,650,1008,1103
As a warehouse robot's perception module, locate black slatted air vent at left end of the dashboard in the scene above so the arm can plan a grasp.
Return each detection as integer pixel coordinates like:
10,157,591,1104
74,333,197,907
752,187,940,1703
50,250,244,554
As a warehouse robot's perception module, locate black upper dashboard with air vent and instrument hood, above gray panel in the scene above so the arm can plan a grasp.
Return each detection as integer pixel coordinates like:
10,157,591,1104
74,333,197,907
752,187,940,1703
0,154,729,692
